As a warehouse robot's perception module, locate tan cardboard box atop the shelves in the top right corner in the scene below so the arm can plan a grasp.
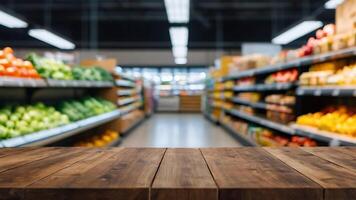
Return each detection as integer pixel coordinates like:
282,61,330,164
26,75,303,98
336,0,356,34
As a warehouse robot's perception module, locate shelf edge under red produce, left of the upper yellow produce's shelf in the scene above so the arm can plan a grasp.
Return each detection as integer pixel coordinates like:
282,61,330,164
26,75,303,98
233,83,296,92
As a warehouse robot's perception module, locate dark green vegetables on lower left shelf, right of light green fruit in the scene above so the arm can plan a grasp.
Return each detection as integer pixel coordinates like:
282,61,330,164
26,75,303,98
58,97,116,121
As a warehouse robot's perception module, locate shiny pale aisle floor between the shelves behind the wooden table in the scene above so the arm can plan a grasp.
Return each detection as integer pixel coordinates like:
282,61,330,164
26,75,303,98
120,113,240,147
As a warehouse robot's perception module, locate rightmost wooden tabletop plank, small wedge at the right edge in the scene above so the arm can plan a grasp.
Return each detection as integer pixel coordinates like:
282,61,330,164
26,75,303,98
303,147,356,173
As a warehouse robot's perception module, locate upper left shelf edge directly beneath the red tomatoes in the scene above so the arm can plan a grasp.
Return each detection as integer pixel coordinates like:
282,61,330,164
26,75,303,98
0,77,47,88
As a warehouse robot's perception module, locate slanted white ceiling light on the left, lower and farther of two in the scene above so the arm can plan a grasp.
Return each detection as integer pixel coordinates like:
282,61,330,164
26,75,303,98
28,29,75,49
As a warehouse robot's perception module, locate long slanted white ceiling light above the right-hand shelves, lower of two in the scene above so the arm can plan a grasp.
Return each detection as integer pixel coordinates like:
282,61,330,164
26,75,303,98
272,21,323,44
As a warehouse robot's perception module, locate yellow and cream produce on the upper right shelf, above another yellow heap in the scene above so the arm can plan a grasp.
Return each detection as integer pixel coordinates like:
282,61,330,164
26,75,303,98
299,63,356,86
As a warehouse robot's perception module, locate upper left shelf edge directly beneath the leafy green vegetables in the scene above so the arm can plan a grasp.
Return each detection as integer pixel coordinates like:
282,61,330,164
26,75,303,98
46,79,114,88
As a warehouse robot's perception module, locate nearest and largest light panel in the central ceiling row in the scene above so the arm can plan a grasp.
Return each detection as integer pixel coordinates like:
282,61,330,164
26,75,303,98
164,0,190,23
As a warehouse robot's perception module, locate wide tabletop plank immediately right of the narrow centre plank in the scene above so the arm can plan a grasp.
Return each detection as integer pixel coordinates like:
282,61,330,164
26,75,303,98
202,148,323,200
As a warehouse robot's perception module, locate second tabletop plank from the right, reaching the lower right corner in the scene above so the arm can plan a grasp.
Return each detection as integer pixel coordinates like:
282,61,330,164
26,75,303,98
266,148,356,200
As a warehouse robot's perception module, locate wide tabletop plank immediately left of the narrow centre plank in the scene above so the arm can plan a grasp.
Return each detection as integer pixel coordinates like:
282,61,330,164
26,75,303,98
26,148,165,200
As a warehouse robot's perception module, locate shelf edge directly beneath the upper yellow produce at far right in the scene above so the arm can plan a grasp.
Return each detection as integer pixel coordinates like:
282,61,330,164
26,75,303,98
296,86,356,97
